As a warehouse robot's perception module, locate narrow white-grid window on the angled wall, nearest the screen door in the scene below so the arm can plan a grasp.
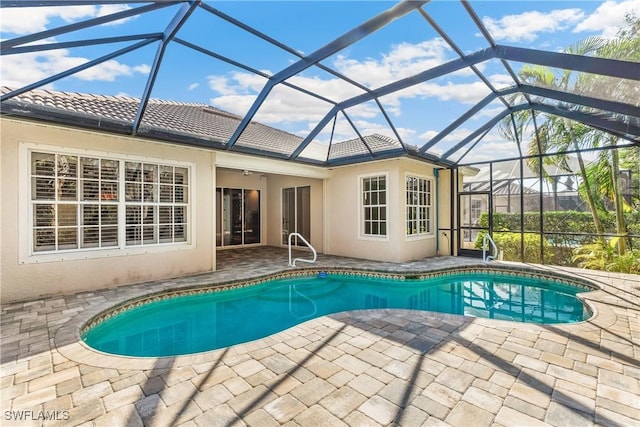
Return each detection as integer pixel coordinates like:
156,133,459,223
405,176,433,236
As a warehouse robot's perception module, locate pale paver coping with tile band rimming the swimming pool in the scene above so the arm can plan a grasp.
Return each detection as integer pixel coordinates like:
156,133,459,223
53,263,616,369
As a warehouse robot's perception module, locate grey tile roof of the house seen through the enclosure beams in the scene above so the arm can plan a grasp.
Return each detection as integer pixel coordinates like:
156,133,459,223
1,87,402,163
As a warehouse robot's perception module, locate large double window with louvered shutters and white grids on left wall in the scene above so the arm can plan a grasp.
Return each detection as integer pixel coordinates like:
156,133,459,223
30,152,189,253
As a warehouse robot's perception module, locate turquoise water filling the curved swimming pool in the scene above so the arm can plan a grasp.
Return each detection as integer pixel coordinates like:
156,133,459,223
83,274,590,357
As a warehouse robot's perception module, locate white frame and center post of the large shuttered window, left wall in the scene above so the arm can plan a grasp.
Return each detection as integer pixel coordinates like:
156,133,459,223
18,141,196,264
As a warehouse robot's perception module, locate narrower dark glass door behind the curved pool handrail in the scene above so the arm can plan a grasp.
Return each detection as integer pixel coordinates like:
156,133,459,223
282,186,311,246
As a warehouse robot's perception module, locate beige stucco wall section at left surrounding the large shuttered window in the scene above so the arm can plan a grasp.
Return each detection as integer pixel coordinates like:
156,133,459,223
0,118,215,302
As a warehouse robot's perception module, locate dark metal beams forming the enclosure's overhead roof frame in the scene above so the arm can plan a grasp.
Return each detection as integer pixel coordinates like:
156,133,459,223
0,0,640,167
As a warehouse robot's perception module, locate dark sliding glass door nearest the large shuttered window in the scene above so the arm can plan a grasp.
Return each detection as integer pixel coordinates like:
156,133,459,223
216,188,260,246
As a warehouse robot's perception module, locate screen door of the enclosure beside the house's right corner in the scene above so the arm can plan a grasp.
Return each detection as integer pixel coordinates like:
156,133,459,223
458,192,491,257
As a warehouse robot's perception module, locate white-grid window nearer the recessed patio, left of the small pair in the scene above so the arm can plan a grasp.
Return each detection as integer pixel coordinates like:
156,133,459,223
361,175,387,237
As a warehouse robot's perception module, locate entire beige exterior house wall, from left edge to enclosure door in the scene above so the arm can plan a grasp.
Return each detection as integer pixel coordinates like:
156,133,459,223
0,118,455,302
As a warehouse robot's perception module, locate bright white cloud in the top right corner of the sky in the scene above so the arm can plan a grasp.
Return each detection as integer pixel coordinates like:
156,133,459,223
573,0,640,38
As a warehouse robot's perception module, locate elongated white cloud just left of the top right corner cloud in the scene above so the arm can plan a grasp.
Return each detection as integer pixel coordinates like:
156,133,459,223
482,9,584,42
